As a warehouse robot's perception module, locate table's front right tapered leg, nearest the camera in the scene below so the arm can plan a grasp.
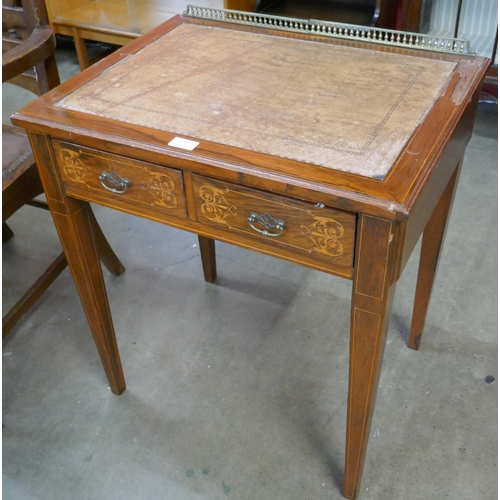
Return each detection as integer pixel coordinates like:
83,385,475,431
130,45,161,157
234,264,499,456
344,215,395,499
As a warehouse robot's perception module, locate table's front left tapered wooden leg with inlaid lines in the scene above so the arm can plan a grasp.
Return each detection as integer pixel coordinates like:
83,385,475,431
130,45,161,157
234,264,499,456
29,132,125,394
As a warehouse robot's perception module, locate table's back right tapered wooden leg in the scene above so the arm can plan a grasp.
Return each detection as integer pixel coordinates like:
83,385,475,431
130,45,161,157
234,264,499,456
408,165,460,350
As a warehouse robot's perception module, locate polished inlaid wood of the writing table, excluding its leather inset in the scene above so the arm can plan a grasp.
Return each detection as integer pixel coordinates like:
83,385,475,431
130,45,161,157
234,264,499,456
14,16,489,498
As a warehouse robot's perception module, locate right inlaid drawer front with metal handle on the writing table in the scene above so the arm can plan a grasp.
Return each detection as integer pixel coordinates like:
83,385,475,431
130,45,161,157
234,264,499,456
193,175,356,268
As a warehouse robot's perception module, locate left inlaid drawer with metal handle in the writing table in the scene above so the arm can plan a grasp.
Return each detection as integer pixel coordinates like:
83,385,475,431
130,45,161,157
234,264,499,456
52,141,187,219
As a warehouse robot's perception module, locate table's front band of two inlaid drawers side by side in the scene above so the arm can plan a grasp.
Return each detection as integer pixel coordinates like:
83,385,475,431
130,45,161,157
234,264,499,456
52,140,357,279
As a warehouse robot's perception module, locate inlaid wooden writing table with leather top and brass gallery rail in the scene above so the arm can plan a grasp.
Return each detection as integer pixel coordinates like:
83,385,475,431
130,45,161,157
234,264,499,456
13,7,488,498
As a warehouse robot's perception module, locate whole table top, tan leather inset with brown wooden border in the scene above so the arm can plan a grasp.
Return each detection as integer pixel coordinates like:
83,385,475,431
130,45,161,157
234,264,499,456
12,11,489,219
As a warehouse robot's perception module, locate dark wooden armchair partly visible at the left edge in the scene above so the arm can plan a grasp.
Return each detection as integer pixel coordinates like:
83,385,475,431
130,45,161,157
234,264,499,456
2,0,125,338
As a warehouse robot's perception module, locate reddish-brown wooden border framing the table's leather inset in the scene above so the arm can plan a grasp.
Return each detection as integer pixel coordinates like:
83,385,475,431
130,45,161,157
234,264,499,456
14,17,488,220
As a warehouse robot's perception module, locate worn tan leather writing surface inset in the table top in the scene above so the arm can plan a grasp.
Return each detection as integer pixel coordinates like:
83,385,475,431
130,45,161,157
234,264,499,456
56,24,455,178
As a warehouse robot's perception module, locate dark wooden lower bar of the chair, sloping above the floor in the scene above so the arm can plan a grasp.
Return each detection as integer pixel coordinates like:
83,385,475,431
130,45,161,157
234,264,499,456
2,252,68,338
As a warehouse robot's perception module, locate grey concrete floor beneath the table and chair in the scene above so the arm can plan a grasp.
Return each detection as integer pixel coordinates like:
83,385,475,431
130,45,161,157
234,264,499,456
3,43,498,500
